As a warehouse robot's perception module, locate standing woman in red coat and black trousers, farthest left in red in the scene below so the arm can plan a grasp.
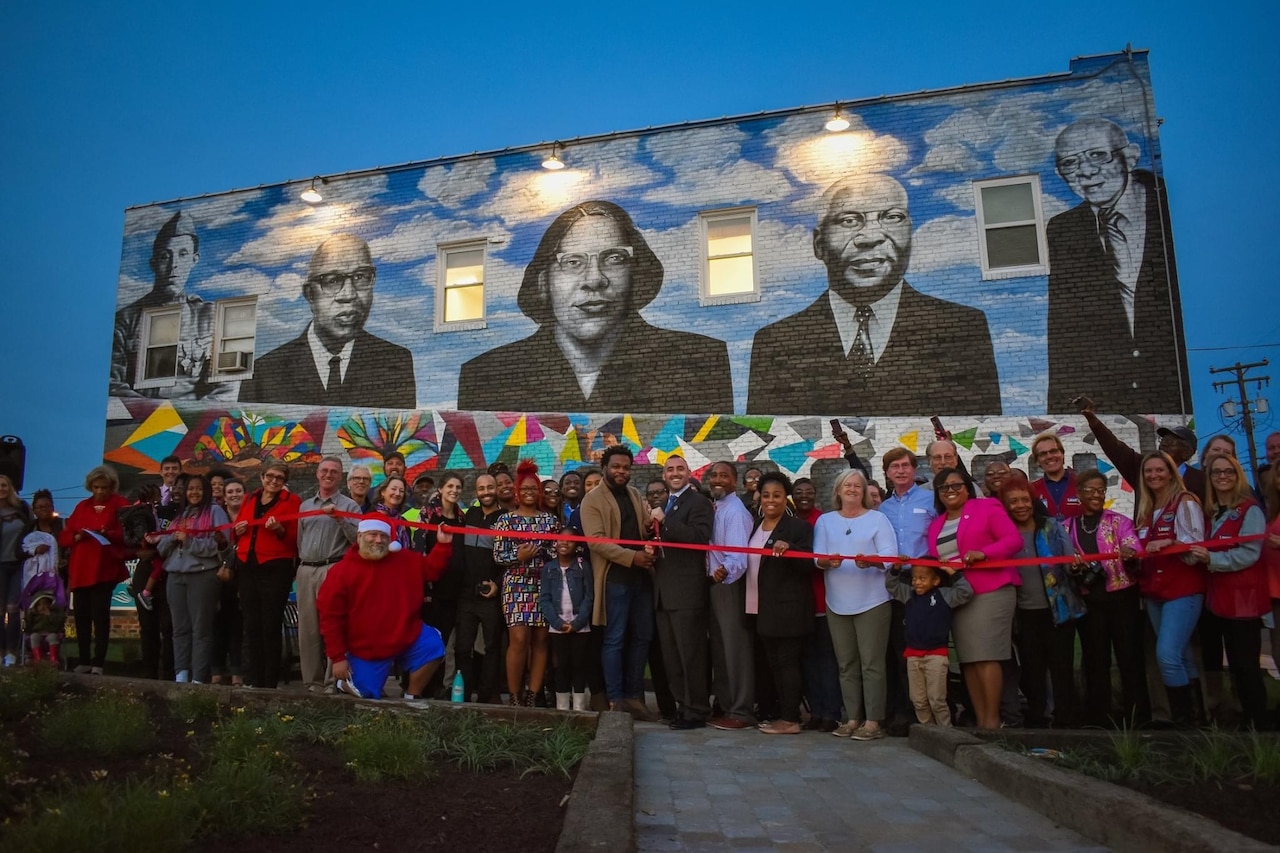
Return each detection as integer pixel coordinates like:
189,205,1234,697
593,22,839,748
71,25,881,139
58,465,129,675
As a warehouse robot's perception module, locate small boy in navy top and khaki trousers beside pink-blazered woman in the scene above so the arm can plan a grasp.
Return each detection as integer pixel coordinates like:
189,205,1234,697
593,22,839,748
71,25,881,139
884,566,973,726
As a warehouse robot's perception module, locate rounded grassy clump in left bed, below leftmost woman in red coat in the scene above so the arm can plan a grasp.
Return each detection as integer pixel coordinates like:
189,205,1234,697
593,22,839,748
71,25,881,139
40,693,155,758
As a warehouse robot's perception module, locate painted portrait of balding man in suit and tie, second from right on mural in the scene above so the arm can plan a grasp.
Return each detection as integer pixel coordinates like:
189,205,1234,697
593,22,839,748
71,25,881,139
746,174,1001,416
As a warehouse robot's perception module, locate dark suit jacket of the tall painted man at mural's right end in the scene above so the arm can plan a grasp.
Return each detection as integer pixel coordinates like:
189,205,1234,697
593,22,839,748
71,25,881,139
1048,170,1192,415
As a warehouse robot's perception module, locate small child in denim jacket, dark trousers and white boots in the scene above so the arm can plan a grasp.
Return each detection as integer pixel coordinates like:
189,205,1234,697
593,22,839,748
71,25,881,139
538,540,595,711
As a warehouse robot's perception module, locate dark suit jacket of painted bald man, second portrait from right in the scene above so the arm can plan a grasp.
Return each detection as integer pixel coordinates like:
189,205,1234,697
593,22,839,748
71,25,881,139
746,283,1001,418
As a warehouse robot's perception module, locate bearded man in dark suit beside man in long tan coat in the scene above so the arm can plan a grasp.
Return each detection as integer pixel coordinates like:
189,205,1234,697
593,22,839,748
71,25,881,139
652,456,716,729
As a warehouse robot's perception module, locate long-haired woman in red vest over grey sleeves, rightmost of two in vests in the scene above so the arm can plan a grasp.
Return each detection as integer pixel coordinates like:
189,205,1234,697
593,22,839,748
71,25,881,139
1192,456,1271,729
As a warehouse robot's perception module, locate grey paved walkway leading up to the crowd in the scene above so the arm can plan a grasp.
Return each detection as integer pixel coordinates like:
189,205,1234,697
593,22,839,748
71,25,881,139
635,724,1106,853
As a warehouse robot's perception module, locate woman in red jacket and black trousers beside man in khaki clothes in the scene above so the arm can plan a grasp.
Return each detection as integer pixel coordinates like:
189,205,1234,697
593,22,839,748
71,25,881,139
233,462,302,688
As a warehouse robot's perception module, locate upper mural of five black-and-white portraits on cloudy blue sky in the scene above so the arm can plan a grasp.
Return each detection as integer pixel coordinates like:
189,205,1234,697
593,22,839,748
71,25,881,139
110,54,1189,422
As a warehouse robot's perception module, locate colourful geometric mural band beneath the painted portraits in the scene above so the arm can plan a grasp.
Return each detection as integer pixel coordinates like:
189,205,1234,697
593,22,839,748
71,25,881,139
106,400,1155,511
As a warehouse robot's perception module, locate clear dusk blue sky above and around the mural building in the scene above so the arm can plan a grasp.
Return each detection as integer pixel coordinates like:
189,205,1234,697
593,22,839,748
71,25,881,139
0,3,1280,499
